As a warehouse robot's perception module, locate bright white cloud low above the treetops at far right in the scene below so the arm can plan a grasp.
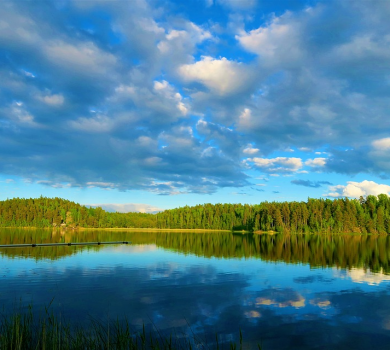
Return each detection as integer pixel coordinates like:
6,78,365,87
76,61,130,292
324,180,390,198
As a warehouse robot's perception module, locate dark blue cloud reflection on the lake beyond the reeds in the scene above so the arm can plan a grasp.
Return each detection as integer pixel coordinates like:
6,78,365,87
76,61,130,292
0,252,390,349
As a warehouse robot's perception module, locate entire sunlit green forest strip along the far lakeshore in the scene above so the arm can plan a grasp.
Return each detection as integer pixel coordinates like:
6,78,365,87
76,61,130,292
0,194,390,234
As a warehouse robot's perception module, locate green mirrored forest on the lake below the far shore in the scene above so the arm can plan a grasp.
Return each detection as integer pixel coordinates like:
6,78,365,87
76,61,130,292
0,229,390,276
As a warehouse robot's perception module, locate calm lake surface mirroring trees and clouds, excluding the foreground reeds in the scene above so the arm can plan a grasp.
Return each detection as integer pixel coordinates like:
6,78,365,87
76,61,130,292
0,229,390,349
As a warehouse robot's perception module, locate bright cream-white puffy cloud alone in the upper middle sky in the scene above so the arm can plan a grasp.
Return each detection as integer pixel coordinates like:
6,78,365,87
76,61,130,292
179,56,249,95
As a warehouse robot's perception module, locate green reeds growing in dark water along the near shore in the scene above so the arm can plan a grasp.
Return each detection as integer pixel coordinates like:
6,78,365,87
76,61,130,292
0,306,262,350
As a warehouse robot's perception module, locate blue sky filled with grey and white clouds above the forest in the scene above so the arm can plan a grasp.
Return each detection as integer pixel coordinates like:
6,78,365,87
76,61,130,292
0,0,390,212
